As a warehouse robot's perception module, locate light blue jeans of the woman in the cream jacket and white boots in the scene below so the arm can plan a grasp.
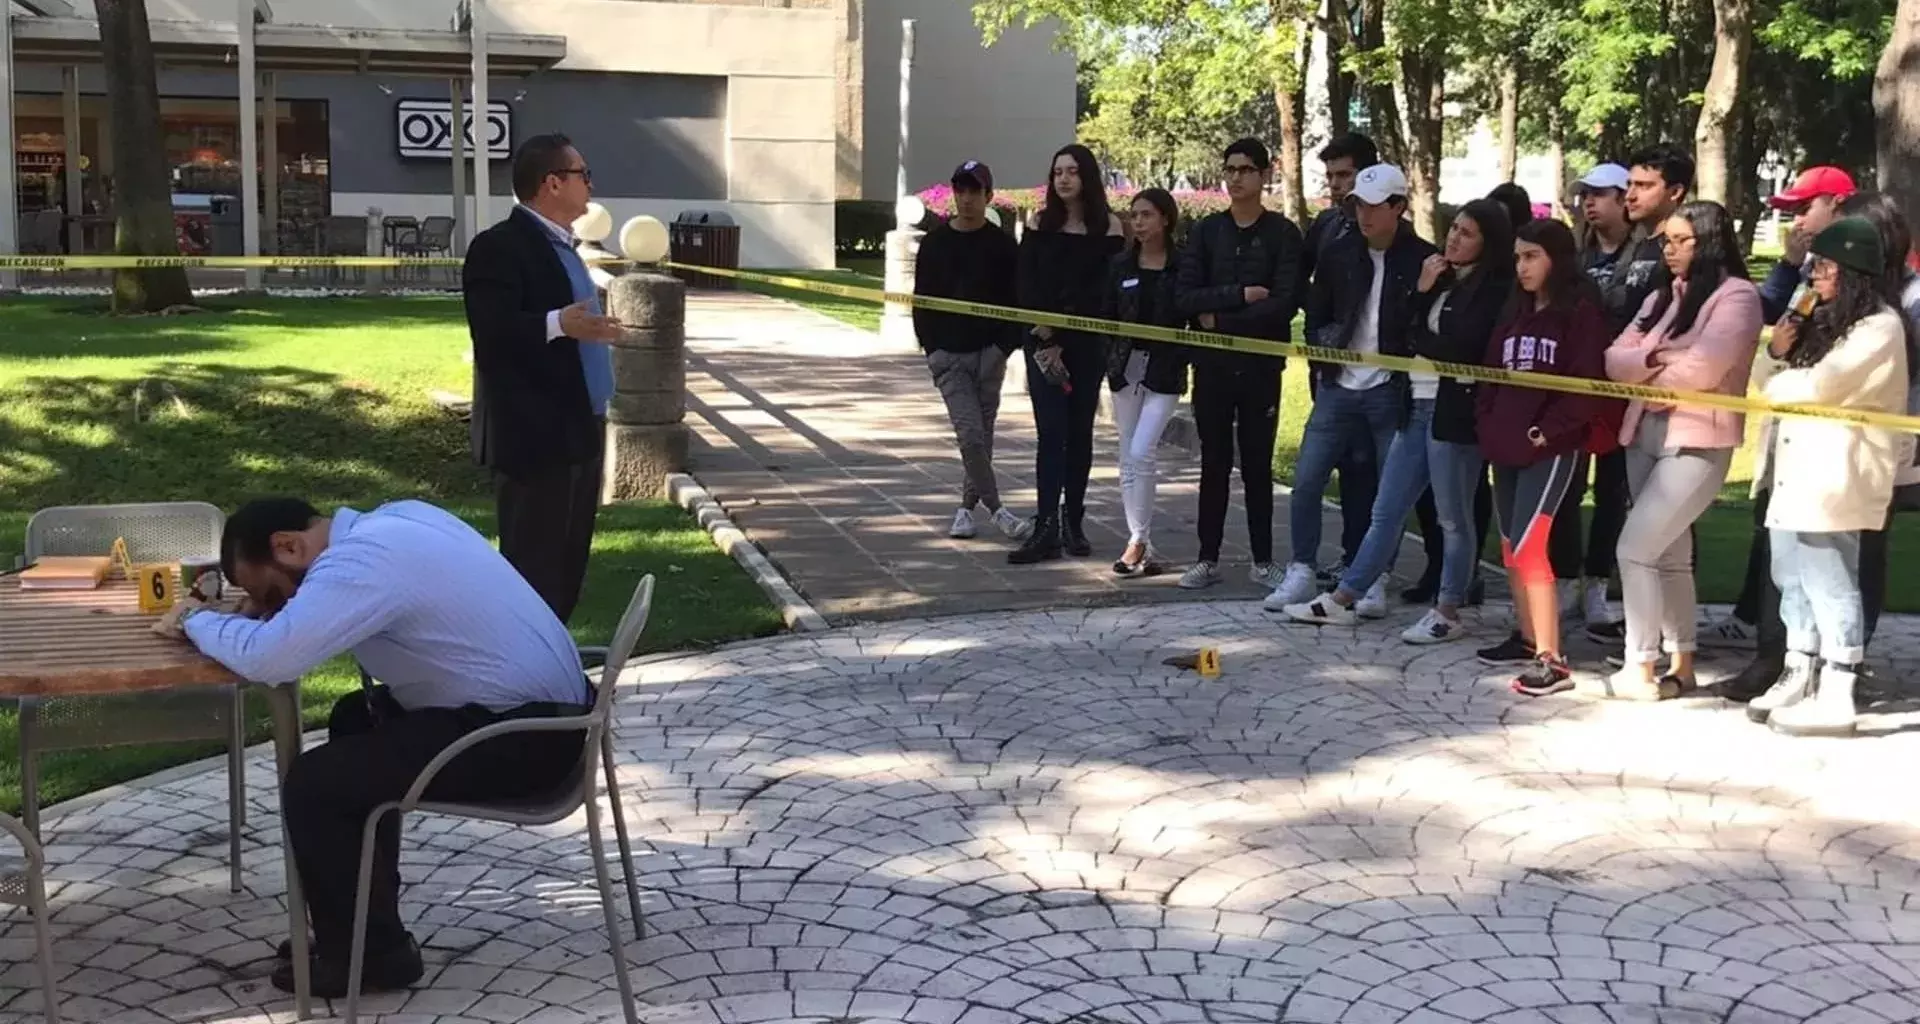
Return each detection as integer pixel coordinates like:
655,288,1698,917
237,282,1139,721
1768,530,1866,667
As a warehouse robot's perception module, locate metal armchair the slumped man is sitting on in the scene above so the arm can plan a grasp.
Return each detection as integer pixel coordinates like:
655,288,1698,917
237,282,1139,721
346,576,653,1024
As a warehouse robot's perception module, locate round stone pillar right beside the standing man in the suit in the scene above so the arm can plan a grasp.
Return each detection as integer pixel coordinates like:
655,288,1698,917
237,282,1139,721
601,271,687,501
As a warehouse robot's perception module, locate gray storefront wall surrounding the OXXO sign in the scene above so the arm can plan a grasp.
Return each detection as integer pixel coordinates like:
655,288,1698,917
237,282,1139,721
17,65,728,200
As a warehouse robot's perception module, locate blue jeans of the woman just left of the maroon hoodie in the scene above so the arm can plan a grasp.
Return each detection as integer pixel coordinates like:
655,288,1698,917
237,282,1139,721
1340,398,1482,607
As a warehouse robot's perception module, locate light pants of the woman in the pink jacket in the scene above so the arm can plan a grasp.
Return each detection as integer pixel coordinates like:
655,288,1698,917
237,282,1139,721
1615,413,1734,665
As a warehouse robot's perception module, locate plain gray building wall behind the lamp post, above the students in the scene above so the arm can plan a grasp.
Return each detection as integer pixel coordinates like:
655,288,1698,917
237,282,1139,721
862,0,1075,200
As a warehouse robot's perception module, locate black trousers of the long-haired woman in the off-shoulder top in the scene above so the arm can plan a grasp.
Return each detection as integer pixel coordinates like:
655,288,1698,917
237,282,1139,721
1027,338,1106,524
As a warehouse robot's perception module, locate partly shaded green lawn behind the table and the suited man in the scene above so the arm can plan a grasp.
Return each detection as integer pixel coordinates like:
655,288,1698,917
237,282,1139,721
0,296,781,811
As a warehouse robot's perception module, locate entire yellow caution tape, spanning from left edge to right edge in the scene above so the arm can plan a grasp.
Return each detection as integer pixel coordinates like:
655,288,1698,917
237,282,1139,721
0,256,1920,432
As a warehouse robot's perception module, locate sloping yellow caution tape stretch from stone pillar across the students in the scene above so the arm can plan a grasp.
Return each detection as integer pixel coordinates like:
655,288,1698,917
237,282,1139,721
662,263,1920,432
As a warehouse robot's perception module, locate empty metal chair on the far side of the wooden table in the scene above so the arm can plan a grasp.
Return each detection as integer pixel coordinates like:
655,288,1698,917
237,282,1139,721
19,501,246,891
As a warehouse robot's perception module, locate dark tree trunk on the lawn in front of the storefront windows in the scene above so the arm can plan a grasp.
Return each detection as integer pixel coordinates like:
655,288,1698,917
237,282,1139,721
94,0,194,313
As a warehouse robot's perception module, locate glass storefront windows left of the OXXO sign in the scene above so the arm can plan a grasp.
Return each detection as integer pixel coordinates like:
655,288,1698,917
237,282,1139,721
13,94,332,254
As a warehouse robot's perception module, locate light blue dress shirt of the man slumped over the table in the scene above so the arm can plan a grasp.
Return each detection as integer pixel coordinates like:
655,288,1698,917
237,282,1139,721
186,501,591,711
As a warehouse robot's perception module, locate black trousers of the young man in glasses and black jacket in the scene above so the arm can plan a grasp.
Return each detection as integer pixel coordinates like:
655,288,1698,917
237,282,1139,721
1192,367,1281,565
